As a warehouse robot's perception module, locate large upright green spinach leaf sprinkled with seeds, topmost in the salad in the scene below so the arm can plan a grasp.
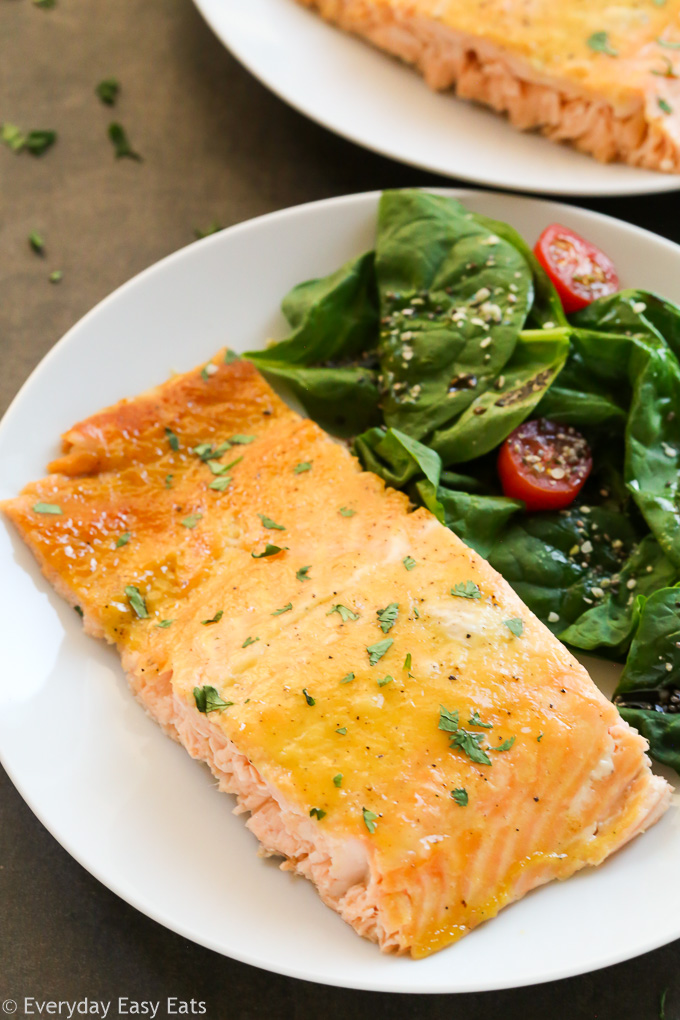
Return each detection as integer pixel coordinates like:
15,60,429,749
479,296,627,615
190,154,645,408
375,191,533,439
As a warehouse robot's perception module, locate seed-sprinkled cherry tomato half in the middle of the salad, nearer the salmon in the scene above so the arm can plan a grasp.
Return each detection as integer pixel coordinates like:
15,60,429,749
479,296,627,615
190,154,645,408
499,418,592,510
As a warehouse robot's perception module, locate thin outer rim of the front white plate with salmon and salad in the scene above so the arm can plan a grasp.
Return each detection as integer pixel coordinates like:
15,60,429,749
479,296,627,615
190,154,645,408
0,187,680,995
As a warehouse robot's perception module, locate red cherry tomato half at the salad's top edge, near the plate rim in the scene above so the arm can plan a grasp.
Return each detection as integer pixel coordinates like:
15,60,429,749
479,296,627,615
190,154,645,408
533,223,619,313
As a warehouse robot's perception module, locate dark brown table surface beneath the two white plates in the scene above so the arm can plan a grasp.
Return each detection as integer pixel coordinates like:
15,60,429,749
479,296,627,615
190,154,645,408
0,0,680,1020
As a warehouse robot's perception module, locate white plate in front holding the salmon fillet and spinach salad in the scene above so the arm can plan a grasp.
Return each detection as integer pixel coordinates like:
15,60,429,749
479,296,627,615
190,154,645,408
0,192,680,991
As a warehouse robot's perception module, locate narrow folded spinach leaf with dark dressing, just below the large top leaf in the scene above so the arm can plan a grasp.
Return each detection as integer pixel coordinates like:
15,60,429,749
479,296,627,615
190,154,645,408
430,328,569,464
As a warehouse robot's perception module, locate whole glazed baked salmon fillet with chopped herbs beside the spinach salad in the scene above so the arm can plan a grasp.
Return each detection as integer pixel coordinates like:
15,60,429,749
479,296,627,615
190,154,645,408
2,352,671,957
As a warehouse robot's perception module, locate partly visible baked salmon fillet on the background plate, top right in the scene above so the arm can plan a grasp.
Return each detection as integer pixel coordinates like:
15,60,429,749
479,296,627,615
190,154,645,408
299,0,680,173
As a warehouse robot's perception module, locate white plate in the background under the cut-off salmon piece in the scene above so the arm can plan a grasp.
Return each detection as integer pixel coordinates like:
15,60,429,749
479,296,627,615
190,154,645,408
194,0,680,195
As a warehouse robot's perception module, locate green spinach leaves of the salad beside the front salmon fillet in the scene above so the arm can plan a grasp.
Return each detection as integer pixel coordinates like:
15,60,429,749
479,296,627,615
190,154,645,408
247,191,680,770
